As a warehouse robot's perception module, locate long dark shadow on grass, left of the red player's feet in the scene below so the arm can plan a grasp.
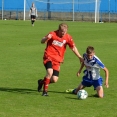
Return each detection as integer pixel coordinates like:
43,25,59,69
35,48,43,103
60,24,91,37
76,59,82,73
0,87,37,94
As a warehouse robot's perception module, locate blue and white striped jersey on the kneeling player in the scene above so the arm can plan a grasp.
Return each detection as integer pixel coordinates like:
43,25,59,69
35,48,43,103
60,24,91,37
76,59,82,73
83,53,105,80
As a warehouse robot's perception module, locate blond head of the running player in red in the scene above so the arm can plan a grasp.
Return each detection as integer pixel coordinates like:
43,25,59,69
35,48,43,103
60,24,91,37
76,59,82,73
58,23,68,37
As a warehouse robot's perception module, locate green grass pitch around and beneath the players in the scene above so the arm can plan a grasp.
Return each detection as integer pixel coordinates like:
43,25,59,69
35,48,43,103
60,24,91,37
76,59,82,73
0,20,117,117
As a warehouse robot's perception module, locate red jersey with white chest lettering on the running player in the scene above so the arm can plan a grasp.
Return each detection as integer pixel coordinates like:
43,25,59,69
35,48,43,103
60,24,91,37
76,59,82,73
44,30,75,62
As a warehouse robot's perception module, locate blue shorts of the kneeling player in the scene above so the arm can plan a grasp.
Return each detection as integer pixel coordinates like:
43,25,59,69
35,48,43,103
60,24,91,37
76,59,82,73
82,76,103,90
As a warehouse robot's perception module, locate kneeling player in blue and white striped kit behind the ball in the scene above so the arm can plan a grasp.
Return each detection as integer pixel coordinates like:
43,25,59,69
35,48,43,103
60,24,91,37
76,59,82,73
66,46,109,98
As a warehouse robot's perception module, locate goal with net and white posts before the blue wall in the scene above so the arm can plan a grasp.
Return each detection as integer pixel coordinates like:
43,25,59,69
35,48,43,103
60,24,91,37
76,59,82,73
24,0,100,23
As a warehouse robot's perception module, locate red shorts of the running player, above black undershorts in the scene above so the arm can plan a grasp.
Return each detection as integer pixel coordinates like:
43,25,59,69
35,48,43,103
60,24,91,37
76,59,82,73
43,56,60,71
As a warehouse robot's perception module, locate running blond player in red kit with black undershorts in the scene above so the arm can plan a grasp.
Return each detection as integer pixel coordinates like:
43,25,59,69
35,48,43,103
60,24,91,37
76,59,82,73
38,23,83,96
